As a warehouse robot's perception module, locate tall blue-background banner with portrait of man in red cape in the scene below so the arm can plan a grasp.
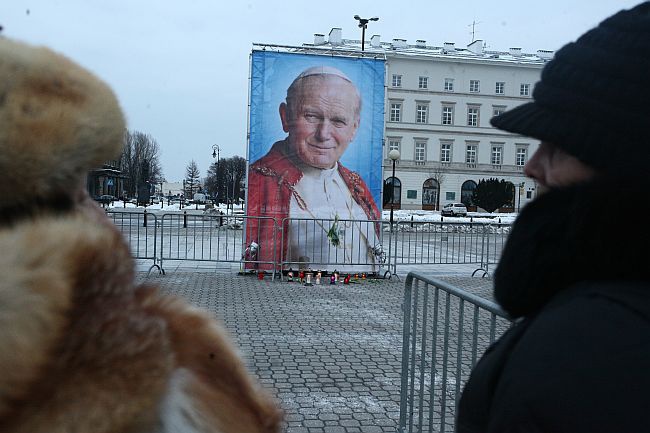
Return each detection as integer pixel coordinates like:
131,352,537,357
246,51,385,272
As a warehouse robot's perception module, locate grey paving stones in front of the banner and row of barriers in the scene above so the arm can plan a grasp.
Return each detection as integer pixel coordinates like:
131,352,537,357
138,269,492,433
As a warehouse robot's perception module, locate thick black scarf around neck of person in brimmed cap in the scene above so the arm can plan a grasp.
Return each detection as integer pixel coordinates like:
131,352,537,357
494,178,650,317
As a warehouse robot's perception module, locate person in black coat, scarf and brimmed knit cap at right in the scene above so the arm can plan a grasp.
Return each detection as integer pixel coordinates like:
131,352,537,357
456,2,650,433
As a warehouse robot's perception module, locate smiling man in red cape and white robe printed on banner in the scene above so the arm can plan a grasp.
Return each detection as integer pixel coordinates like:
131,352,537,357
247,66,381,269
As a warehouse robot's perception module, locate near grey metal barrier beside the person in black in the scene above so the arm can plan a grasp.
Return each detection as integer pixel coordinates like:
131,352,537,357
398,272,511,433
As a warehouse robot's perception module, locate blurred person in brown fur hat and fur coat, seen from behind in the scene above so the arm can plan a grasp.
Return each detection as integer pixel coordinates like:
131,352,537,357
0,37,281,433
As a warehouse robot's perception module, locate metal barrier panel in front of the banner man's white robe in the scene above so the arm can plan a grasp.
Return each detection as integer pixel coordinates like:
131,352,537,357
279,218,386,273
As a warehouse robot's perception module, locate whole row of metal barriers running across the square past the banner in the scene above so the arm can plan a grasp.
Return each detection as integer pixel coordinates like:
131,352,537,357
107,210,510,276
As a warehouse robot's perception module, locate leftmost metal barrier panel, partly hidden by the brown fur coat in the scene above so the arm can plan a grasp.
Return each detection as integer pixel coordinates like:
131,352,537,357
106,210,159,270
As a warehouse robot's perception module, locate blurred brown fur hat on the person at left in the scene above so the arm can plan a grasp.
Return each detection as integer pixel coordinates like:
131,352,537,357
0,37,125,203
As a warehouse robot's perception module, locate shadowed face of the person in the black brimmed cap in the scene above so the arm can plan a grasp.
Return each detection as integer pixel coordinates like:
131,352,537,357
524,142,595,193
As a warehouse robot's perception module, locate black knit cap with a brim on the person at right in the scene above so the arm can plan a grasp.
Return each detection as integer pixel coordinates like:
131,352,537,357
490,2,650,174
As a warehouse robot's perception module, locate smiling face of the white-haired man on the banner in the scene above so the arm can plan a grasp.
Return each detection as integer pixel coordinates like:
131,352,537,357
280,76,359,169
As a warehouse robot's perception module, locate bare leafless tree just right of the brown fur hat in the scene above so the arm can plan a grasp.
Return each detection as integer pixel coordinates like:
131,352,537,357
120,130,164,197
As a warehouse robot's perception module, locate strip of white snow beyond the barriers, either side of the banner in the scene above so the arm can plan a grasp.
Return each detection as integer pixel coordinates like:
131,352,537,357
108,201,517,224
